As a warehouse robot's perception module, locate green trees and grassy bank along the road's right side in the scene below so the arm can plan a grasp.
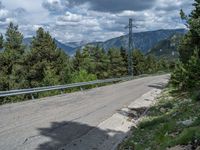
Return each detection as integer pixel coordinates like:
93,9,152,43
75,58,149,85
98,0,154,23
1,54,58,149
119,0,200,150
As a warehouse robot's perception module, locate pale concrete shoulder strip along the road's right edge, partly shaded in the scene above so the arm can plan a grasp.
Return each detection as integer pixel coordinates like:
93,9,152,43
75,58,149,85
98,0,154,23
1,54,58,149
61,89,162,150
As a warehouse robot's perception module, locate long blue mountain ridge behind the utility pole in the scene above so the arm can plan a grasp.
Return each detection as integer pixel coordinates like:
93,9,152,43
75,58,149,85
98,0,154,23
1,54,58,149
87,29,187,54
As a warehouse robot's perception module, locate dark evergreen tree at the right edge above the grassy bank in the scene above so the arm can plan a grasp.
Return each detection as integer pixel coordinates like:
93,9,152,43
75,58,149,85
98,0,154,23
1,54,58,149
171,0,200,90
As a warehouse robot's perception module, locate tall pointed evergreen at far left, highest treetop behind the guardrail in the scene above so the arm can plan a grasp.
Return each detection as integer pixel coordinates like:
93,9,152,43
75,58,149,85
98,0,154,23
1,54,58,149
2,23,27,90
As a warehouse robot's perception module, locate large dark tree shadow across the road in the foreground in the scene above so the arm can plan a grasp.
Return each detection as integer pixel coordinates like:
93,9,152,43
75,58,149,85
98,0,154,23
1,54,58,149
37,122,126,150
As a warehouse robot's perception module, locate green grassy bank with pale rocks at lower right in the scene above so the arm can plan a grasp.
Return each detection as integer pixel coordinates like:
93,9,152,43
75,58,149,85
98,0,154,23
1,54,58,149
119,88,200,150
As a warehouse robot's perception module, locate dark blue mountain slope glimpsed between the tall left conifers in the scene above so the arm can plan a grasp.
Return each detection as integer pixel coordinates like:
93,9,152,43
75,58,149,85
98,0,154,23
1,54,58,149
23,38,76,55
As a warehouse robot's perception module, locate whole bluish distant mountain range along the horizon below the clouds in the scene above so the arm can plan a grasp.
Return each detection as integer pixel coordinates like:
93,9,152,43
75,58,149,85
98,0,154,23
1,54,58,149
24,29,187,55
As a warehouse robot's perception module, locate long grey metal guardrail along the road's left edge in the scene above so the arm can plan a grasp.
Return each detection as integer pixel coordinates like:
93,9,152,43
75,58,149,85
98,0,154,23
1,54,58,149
0,76,133,98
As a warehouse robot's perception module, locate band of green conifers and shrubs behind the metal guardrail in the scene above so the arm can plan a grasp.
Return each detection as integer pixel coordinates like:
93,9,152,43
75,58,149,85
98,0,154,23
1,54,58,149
0,23,171,104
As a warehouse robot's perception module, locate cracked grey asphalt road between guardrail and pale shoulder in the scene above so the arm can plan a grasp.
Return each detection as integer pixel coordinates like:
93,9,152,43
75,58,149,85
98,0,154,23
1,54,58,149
0,75,169,150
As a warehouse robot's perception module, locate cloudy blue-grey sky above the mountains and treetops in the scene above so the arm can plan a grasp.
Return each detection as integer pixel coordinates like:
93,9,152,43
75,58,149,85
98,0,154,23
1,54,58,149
0,0,193,43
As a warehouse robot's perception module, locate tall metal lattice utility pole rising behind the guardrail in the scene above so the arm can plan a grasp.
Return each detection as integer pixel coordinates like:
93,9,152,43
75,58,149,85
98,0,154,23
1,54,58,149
125,18,134,76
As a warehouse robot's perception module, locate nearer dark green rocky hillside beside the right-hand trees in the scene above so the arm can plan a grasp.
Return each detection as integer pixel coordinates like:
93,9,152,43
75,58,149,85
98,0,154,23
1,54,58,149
147,33,183,60
